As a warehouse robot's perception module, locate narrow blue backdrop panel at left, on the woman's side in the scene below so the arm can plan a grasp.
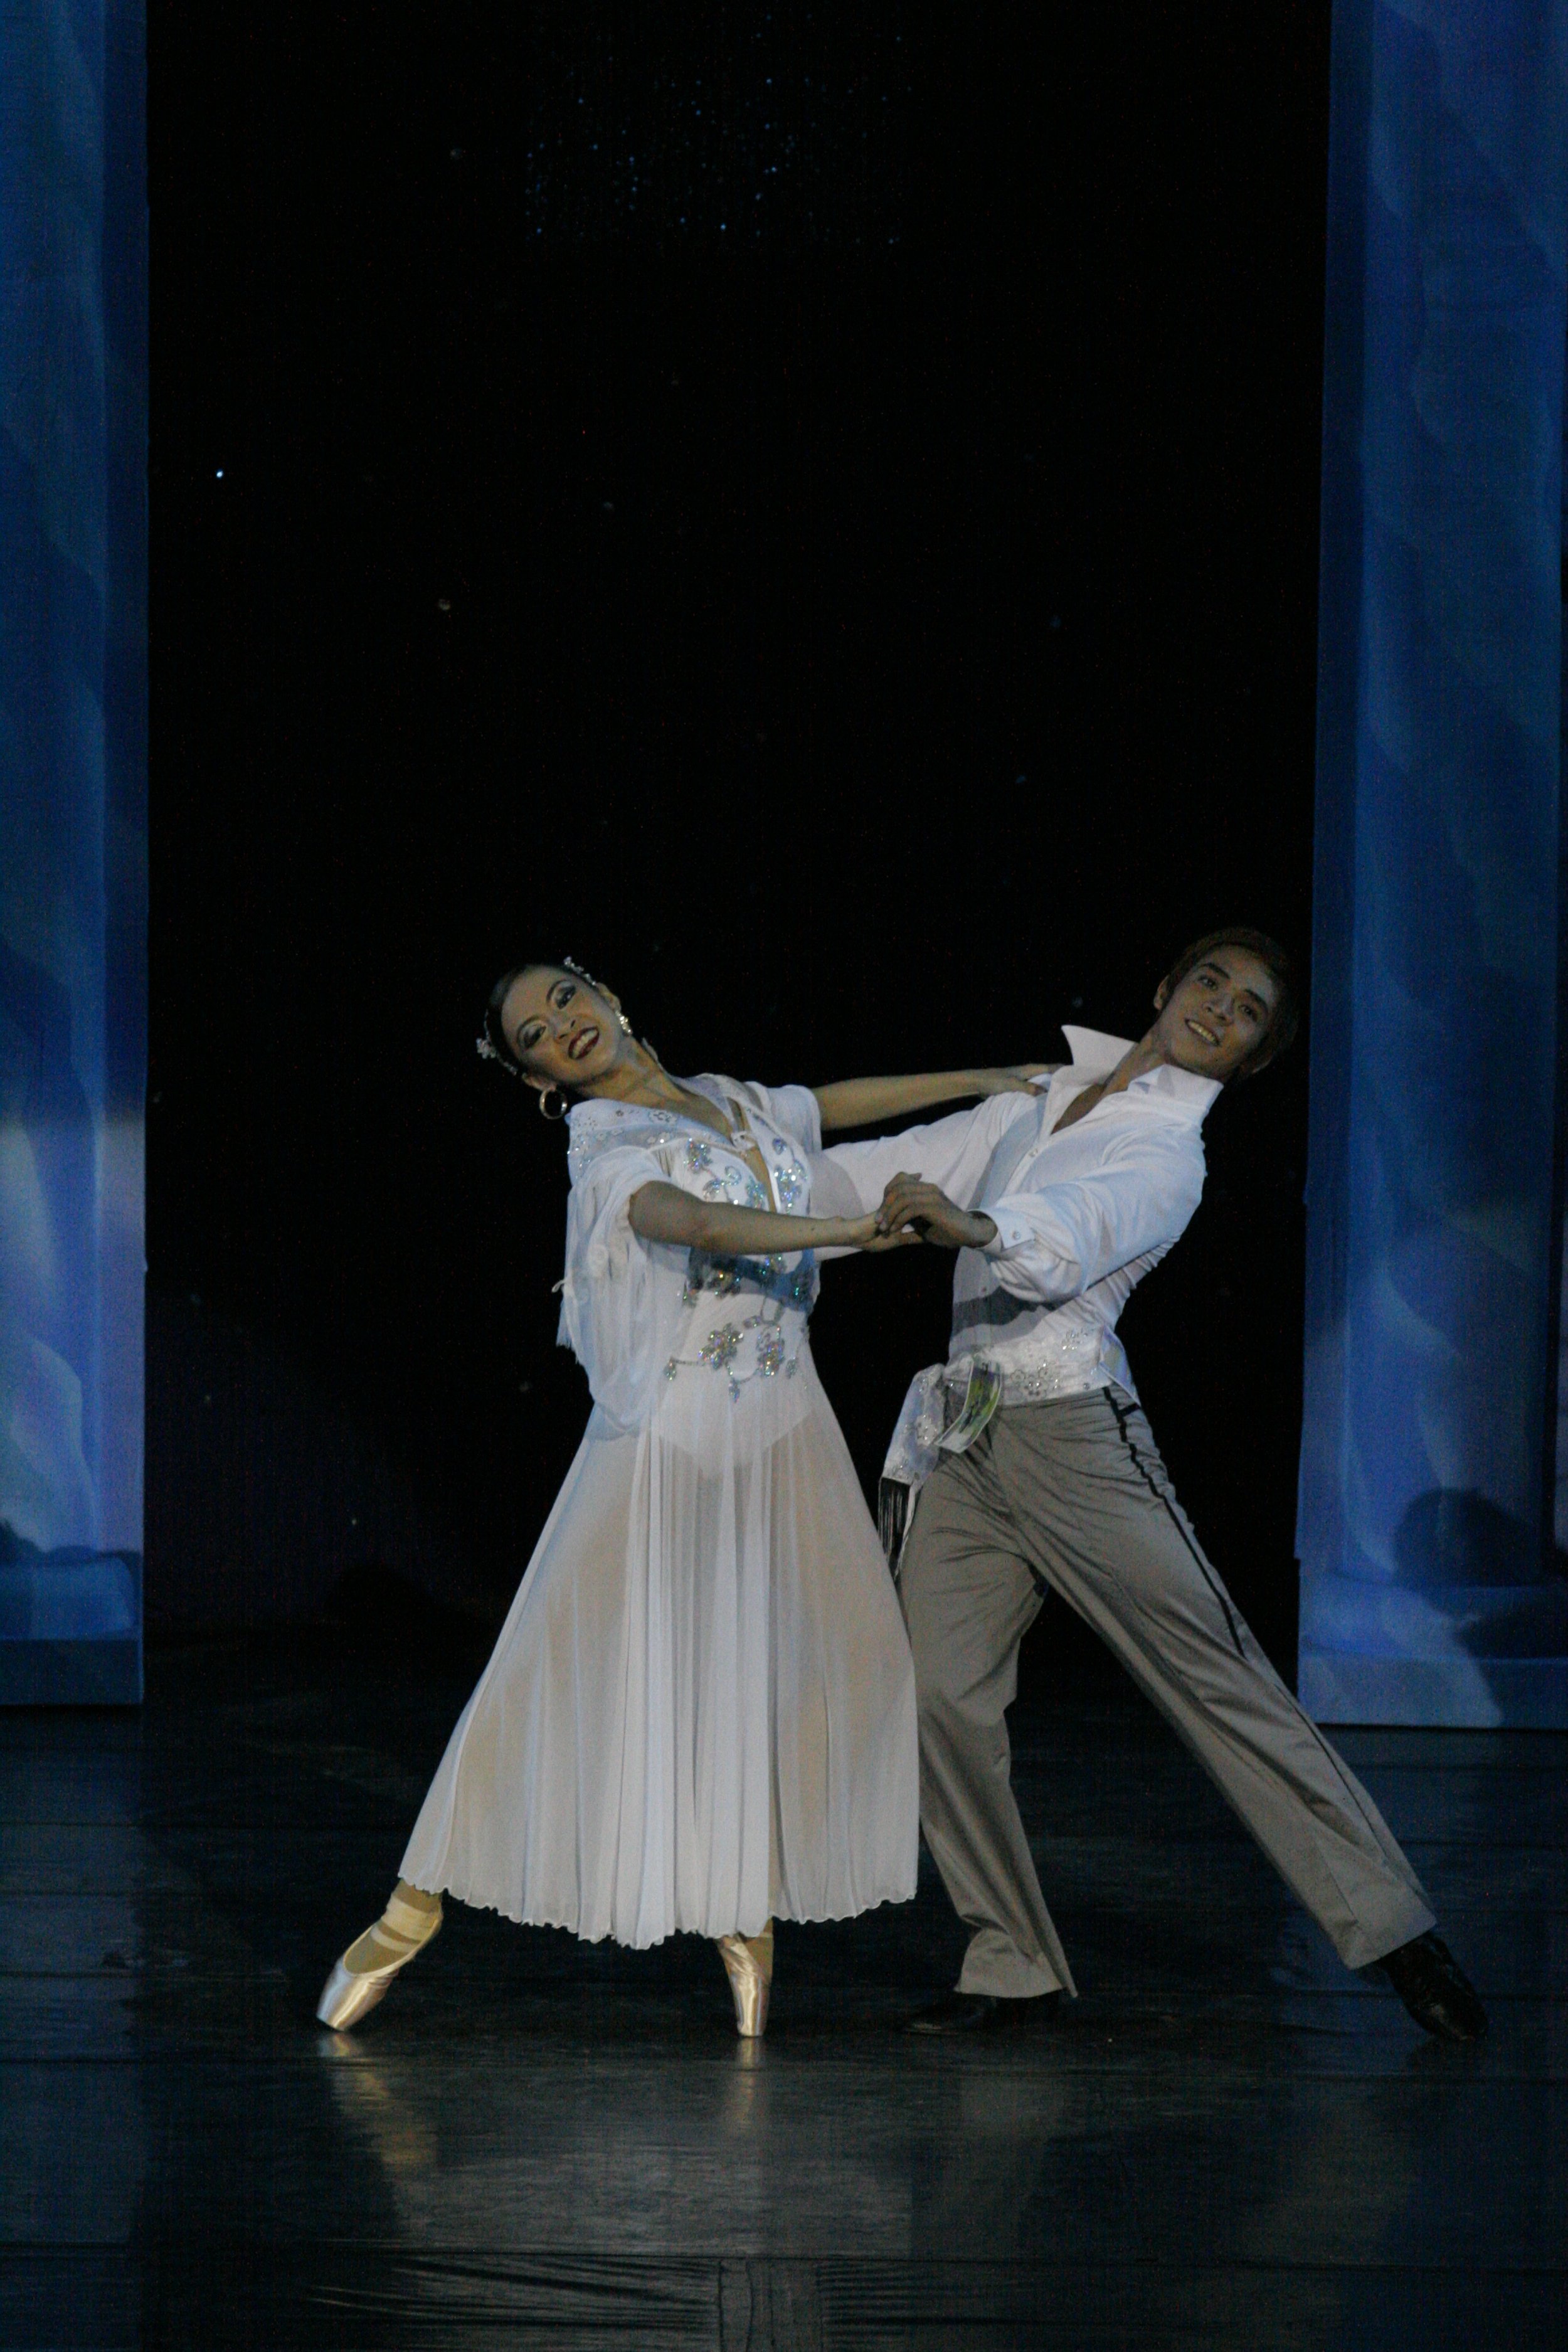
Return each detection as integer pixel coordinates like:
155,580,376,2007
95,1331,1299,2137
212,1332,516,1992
0,0,146,1703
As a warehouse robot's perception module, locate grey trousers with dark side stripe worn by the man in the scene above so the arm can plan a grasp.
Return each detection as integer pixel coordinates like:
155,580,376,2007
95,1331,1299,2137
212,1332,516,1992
901,1388,1434,1997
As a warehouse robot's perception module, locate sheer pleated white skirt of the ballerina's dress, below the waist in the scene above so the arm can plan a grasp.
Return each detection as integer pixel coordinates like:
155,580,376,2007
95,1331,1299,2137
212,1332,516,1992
402,1348,919,1945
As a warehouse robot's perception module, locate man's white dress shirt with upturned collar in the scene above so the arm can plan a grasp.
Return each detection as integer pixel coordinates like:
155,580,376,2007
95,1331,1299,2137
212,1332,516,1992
825,1028,1220,1475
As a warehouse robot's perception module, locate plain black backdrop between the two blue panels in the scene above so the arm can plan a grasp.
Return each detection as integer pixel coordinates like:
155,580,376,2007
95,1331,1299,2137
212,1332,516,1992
148,0,1328,1656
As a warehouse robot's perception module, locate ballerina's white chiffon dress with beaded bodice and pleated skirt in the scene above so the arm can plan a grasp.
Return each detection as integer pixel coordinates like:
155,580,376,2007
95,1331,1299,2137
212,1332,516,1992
402,1078,919,1945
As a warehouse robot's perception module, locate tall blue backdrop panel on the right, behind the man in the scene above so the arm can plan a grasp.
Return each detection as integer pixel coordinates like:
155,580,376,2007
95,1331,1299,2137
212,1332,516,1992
1300,0,1568,1724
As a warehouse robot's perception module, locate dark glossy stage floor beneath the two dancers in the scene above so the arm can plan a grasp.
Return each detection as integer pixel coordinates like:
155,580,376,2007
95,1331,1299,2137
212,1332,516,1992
0,1618,1568,2352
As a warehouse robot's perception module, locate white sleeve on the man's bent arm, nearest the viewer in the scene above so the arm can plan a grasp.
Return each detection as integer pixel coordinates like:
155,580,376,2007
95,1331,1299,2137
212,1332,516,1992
983,1143,1204,1308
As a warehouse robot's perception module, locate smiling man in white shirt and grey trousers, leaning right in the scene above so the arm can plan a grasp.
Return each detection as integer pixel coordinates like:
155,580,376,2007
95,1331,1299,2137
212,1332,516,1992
830,929,1486,2042
